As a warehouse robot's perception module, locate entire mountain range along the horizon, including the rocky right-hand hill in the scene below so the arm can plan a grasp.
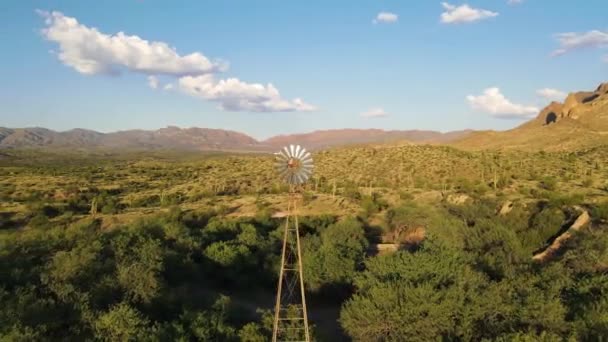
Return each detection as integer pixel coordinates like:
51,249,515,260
0,83,608,152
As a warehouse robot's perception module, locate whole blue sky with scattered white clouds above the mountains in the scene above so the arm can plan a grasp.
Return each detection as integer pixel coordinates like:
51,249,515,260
0,0,608,138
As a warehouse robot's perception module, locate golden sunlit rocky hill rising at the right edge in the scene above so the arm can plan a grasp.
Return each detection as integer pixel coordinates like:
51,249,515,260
452,83,608,151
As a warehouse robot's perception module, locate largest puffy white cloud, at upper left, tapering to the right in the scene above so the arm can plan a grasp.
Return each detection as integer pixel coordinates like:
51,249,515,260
39,11,225,76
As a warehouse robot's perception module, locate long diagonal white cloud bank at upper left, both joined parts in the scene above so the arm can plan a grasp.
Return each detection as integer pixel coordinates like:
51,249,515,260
38,11,315,112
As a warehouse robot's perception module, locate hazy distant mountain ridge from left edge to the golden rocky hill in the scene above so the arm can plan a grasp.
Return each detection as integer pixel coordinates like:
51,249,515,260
0,127,470,151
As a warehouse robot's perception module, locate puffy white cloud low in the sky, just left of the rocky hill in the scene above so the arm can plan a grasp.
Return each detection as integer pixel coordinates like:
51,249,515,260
467,87,539,119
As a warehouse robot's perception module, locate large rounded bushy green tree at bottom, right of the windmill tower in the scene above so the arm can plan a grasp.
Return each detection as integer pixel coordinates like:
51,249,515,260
340,241,486,341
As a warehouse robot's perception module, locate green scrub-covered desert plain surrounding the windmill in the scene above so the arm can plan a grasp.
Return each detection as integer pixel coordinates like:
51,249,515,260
0,145,608,341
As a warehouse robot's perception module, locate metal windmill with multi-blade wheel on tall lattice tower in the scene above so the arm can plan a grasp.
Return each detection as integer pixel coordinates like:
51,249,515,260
272,145,313,342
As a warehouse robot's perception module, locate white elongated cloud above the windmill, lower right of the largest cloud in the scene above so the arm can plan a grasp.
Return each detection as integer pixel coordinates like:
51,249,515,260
179,75,316,112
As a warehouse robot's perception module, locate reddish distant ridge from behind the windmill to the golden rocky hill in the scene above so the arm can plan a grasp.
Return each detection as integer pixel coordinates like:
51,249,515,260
262,129,472,149
